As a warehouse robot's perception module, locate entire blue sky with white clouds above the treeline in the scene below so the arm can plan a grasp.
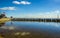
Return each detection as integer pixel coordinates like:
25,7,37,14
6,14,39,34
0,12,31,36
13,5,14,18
0,0,60,18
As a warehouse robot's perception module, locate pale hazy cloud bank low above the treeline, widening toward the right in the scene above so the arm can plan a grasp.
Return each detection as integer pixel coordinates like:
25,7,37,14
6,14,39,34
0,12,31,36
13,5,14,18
20,10,60,18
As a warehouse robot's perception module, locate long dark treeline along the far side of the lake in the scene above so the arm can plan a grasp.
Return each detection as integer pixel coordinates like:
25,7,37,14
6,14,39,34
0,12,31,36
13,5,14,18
12,18,60,22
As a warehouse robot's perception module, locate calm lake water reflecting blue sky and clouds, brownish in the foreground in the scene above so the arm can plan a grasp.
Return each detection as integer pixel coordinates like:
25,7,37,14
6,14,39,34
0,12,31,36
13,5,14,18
0,21,60,38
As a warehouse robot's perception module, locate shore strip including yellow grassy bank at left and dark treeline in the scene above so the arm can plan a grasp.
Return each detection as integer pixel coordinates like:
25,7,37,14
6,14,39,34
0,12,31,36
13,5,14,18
0,18,60,23
